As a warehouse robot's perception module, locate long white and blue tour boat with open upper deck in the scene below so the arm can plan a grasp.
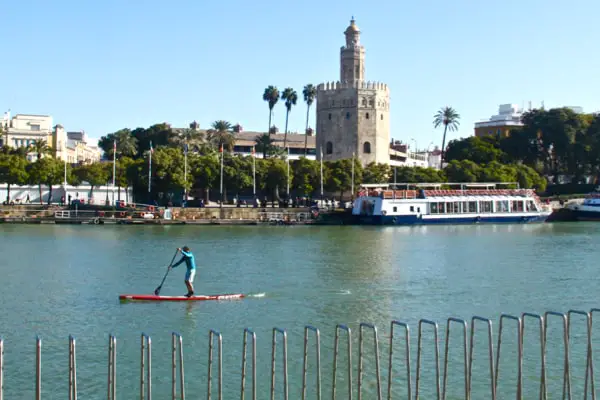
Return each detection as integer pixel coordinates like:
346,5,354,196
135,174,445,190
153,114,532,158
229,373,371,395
352,183,552,225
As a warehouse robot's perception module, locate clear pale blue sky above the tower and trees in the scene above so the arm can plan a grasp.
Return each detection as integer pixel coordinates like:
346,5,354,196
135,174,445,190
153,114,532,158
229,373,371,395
0,0,600,147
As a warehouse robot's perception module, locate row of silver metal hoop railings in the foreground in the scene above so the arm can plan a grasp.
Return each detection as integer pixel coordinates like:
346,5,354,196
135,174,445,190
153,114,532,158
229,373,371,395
0,308,600,400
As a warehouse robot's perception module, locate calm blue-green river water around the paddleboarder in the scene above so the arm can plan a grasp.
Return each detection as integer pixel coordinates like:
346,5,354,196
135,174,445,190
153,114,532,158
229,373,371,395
0,223,600,399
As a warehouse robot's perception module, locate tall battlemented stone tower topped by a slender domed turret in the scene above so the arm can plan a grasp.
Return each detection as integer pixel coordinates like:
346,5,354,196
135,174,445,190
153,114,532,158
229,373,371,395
316,18,390,165
